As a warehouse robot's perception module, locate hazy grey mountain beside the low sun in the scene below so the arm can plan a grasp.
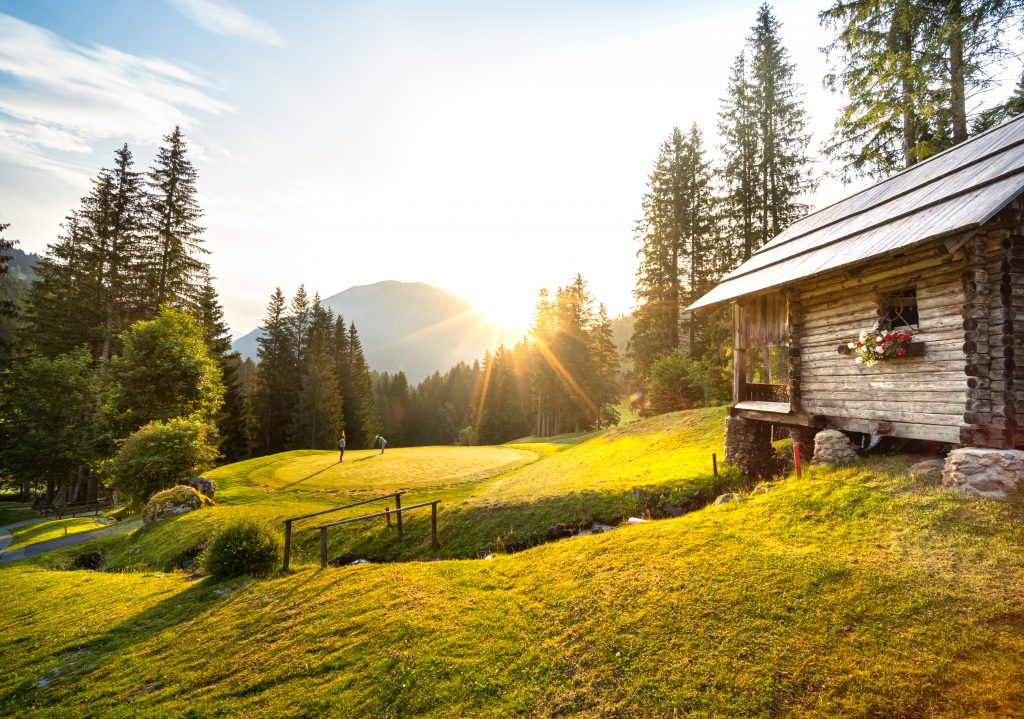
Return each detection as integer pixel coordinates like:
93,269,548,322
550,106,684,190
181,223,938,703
231,280,518,383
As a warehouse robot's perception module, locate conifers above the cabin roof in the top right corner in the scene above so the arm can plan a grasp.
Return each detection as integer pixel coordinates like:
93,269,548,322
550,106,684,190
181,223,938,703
818,0,1021,178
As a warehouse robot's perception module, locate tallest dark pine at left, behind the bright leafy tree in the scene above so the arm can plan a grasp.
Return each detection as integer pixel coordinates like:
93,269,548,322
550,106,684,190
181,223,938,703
146,127,208,311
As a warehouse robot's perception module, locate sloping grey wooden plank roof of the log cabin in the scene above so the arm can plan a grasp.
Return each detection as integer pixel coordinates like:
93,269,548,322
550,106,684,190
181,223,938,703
689,116,1024,309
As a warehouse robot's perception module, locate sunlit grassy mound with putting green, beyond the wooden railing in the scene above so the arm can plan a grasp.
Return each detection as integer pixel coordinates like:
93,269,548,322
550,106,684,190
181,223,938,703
70,409,743,570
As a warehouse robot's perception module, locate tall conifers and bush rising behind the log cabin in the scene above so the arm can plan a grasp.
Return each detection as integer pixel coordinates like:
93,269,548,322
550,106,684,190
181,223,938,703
627,0,1024,413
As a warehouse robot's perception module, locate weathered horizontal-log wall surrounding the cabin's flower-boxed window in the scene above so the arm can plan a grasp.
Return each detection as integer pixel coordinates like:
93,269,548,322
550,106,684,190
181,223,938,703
791,242,968,443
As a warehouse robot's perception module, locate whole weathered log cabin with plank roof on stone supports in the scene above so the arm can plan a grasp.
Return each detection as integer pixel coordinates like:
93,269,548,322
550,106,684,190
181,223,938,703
689,117,1024,498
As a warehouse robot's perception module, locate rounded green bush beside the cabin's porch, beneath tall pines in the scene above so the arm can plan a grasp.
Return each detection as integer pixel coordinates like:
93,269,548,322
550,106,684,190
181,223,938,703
647,349,730,414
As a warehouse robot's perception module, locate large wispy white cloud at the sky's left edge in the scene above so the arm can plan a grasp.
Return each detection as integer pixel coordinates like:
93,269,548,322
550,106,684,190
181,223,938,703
0,13,230,177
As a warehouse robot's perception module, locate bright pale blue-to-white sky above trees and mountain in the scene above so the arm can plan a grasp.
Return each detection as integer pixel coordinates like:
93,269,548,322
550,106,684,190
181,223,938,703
0,0,1018,335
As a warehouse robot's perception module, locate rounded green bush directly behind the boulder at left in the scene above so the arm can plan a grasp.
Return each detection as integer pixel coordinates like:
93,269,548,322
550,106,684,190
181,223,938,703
106,417,217,505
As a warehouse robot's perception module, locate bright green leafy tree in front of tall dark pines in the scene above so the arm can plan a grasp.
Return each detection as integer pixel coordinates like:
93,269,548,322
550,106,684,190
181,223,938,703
110,306,224,431
